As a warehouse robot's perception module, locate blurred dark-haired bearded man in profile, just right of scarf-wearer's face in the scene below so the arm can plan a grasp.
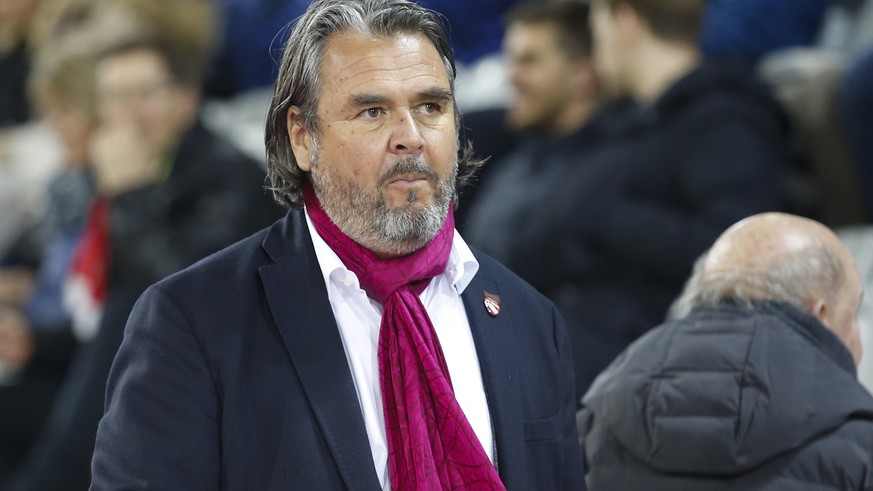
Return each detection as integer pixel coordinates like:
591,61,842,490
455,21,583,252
461,2,614,404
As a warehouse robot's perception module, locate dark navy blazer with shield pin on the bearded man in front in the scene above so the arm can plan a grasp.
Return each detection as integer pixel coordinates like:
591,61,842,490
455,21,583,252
91,211,585,490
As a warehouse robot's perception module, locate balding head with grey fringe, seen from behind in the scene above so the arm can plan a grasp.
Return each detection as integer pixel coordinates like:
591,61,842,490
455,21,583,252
674,213,862,363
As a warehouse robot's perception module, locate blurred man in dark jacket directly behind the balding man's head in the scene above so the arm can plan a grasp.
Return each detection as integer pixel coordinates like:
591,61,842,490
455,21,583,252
548,0,789,395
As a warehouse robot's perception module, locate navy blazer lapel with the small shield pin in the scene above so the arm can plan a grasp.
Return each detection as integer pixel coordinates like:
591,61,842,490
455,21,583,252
462,271,526,487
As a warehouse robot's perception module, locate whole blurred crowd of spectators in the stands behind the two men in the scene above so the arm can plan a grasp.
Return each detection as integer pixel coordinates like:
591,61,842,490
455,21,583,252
0,0,873,490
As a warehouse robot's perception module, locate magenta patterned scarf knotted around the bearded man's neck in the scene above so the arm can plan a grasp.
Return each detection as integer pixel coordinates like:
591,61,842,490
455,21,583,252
304,186,506,491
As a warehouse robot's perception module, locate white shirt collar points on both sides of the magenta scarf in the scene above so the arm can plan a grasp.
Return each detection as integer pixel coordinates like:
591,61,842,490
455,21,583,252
304,207,479,295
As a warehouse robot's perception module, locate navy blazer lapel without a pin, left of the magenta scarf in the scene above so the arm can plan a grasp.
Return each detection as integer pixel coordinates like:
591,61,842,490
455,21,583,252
259,211,380,490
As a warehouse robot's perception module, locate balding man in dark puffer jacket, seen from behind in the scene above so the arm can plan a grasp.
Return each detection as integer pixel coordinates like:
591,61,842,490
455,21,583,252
579,213,873,491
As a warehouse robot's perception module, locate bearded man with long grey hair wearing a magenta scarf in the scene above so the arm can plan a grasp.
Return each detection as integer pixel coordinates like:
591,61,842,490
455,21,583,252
91,0,585,490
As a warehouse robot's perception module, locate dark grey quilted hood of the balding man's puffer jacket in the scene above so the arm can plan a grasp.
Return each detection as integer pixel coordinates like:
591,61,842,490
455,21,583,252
583,304,873,477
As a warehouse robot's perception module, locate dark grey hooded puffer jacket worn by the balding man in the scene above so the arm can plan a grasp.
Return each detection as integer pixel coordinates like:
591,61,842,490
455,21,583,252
579,304,873,491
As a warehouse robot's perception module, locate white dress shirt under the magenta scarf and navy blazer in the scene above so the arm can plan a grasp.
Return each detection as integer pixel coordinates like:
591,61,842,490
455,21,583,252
306,209,494,491
